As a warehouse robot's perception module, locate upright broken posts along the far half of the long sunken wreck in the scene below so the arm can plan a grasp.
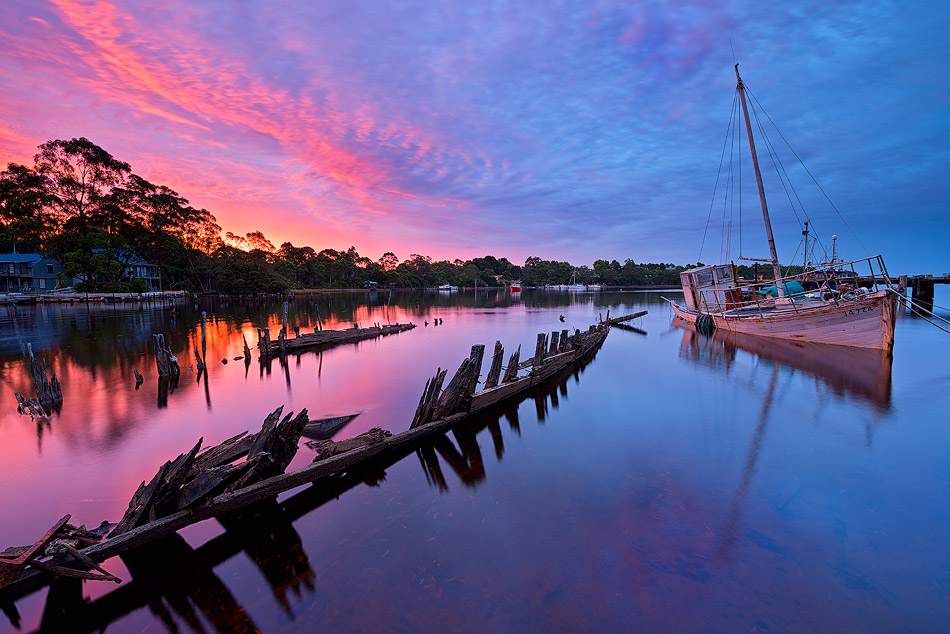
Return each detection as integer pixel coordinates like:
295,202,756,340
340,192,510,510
409,329,580,429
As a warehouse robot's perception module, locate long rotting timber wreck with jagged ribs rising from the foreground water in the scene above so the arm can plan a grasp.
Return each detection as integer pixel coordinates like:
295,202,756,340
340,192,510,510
0,313,642,603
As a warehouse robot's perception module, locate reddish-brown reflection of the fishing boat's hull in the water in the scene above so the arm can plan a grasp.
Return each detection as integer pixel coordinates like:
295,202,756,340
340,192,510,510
673,319,893,409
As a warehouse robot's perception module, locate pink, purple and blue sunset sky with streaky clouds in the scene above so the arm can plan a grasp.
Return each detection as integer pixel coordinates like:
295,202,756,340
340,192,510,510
0,0,950,274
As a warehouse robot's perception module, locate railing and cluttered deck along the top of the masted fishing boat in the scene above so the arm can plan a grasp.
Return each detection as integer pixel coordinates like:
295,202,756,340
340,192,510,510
701,255,894,314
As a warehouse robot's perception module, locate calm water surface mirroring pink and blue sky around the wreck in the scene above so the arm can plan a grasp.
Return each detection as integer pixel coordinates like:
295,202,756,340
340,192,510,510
0,291,950,632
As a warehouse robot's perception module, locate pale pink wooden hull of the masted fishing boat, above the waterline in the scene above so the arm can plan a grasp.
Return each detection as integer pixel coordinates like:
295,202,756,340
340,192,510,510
670,290,897,350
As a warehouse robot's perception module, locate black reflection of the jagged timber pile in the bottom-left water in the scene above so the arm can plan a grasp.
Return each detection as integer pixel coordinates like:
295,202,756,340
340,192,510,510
27,494,314,634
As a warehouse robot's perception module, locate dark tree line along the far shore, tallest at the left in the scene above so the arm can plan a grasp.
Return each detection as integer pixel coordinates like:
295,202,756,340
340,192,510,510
0,138,712,294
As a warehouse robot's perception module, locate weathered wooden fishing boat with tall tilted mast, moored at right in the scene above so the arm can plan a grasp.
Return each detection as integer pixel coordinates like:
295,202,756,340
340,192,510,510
667,64,897,352
